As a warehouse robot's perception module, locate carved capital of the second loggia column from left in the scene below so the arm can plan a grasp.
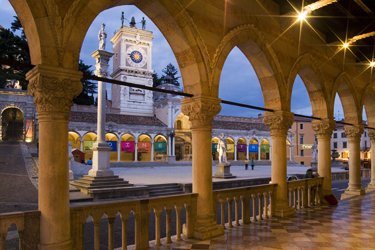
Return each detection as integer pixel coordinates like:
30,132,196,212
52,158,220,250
181,96,221,129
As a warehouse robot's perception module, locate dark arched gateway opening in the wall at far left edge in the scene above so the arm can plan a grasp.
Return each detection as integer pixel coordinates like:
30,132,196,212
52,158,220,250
1,108,24,141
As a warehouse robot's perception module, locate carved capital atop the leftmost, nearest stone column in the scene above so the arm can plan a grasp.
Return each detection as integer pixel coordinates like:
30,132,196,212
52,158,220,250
26,65,82,119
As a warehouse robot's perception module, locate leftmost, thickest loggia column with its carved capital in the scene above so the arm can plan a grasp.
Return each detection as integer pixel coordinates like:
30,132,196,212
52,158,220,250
26,65,82,250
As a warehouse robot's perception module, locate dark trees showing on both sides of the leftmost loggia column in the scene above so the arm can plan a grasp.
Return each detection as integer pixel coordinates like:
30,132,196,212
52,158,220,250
0,16,97,105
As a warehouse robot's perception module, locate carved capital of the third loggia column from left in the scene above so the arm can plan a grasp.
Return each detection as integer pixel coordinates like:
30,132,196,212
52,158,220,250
263,111,294,136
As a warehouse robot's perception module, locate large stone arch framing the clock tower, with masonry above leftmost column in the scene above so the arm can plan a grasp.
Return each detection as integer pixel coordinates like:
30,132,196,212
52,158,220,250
10,0,209,95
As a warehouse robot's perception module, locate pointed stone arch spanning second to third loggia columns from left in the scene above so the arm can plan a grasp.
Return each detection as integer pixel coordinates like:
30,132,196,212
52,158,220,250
211,25,287,110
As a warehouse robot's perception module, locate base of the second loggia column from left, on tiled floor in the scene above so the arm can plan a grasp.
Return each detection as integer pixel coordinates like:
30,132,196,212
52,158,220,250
193,218,224,240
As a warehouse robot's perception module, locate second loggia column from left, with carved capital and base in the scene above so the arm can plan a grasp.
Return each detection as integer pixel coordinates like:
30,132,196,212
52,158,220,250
181,96,224,239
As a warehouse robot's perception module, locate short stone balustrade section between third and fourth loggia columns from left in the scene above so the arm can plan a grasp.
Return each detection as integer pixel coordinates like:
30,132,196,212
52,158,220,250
288,177,323,209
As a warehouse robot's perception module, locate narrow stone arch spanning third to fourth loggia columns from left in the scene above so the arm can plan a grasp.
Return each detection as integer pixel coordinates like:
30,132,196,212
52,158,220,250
287,54,333,118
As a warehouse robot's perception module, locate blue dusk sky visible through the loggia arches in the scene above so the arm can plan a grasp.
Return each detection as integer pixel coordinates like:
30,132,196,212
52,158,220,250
0,0,352,120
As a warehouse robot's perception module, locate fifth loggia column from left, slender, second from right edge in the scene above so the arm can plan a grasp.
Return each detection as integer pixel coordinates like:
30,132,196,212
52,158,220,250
341,125,365,199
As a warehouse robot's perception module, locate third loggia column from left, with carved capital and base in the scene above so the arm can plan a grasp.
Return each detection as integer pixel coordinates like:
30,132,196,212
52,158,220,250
264,111,294,217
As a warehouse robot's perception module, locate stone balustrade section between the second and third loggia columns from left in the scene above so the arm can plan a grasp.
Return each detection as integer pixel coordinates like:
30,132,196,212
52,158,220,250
214,184,276,228
